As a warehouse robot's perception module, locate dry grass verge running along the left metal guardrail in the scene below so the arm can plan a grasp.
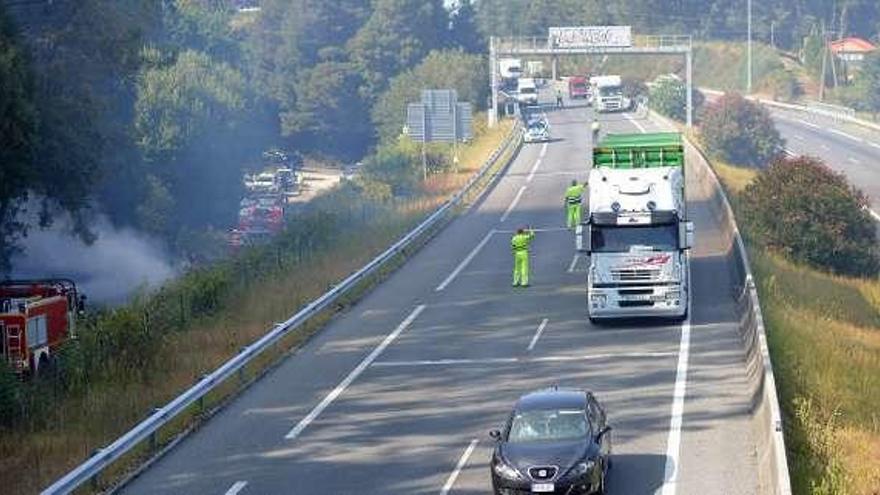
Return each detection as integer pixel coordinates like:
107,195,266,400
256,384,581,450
0,122,510,493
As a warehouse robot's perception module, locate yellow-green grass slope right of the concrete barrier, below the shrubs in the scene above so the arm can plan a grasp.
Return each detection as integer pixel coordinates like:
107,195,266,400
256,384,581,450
713,163,880,495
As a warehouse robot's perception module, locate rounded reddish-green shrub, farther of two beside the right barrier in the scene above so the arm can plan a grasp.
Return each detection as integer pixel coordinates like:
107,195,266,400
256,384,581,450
700,93,784,168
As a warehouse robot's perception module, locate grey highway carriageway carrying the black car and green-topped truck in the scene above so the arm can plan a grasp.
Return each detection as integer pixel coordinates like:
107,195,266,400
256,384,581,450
122,94,764,495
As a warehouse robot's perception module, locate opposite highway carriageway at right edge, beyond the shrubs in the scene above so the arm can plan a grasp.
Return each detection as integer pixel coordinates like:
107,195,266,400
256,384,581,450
766,106,880,221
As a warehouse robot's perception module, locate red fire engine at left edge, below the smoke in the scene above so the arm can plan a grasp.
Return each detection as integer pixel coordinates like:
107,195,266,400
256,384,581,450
0,279,85,375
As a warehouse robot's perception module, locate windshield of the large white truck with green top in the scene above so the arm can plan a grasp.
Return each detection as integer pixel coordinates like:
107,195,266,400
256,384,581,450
591,223,678,253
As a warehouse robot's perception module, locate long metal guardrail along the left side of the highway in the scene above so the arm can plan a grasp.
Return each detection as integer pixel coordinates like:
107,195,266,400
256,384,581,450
41,123,522,495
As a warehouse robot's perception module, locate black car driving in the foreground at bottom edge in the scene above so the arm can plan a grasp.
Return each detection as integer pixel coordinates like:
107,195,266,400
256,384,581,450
489,388,611,495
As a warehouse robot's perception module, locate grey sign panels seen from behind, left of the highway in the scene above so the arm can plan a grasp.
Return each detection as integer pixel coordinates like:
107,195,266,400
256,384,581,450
406,89,474,143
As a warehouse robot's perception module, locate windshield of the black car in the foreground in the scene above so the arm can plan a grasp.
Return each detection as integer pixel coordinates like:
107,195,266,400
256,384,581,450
507,409,590,443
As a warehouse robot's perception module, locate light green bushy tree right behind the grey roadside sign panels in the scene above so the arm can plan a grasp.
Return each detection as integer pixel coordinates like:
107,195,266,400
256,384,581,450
373,50,489,142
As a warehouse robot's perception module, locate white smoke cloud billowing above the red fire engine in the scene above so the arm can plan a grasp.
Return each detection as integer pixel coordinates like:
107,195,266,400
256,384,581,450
12,216,176,304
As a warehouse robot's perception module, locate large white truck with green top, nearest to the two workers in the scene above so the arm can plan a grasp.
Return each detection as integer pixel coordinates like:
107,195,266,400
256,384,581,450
577,133,693,321
